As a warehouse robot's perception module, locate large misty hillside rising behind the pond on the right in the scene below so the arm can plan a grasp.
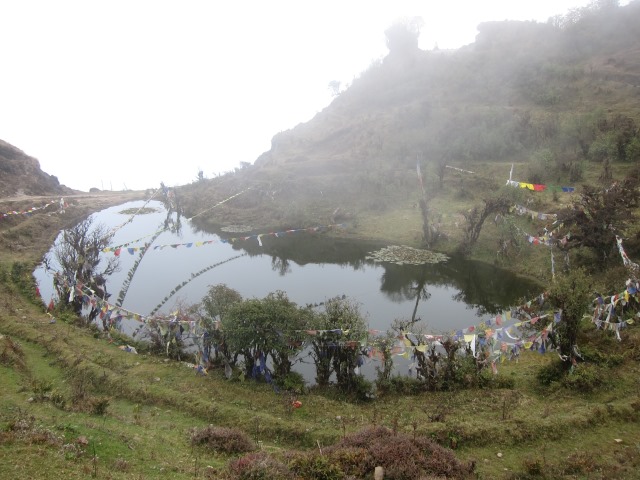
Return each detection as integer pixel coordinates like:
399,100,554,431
180,1,640,266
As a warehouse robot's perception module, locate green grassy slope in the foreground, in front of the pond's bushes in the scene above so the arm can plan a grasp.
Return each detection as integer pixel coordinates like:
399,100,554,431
0,170,640,479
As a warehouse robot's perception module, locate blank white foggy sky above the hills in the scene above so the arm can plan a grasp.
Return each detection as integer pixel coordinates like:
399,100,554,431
0,0,608,191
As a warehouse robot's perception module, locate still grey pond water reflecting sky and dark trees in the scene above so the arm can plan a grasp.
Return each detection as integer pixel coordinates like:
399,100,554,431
34,201,541,334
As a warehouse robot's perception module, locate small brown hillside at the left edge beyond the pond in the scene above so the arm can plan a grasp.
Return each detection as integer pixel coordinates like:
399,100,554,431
0,140,74,198
